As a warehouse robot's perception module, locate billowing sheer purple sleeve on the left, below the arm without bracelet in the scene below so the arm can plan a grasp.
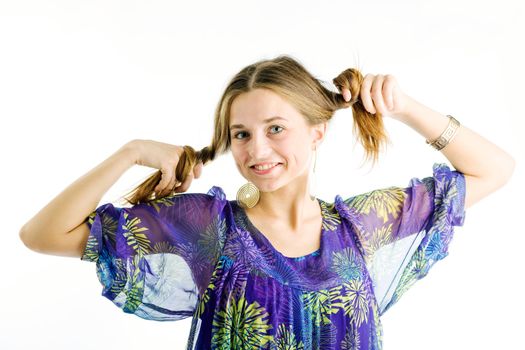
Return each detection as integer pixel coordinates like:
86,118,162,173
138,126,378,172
81,186,227,321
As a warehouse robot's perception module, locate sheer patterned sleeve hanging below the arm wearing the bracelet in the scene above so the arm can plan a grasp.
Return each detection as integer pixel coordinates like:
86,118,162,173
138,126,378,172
336,163,466,314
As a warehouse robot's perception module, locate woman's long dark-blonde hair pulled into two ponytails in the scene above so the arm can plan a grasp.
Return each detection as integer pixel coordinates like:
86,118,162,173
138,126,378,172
121,55,388,205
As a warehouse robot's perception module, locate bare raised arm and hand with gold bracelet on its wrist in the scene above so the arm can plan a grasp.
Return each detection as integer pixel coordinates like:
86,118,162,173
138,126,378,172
343,74,515,208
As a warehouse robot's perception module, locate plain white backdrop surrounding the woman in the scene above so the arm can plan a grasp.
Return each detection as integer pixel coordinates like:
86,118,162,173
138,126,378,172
0,0,525,350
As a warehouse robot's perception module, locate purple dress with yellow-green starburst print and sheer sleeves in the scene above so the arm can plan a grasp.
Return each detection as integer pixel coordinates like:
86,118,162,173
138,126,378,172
81,163,465,350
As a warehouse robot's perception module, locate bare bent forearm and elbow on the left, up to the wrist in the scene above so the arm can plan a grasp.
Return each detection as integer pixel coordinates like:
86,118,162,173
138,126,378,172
20,141,137,257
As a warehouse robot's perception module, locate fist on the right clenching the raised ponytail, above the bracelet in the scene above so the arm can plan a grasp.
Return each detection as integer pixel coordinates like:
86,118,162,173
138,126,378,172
342,74,409,119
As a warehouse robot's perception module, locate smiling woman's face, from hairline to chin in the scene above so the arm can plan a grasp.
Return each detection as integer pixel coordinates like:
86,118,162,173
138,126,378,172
230,89,326,192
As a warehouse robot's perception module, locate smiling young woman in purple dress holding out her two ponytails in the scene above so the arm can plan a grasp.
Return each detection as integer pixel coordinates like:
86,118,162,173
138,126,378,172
20,56,514,349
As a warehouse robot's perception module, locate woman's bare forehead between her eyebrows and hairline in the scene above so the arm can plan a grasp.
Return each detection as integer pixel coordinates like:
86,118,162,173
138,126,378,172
230,89,302,126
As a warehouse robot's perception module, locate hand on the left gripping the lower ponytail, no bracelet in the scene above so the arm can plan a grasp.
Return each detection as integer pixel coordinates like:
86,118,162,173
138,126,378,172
128,139,203,197
